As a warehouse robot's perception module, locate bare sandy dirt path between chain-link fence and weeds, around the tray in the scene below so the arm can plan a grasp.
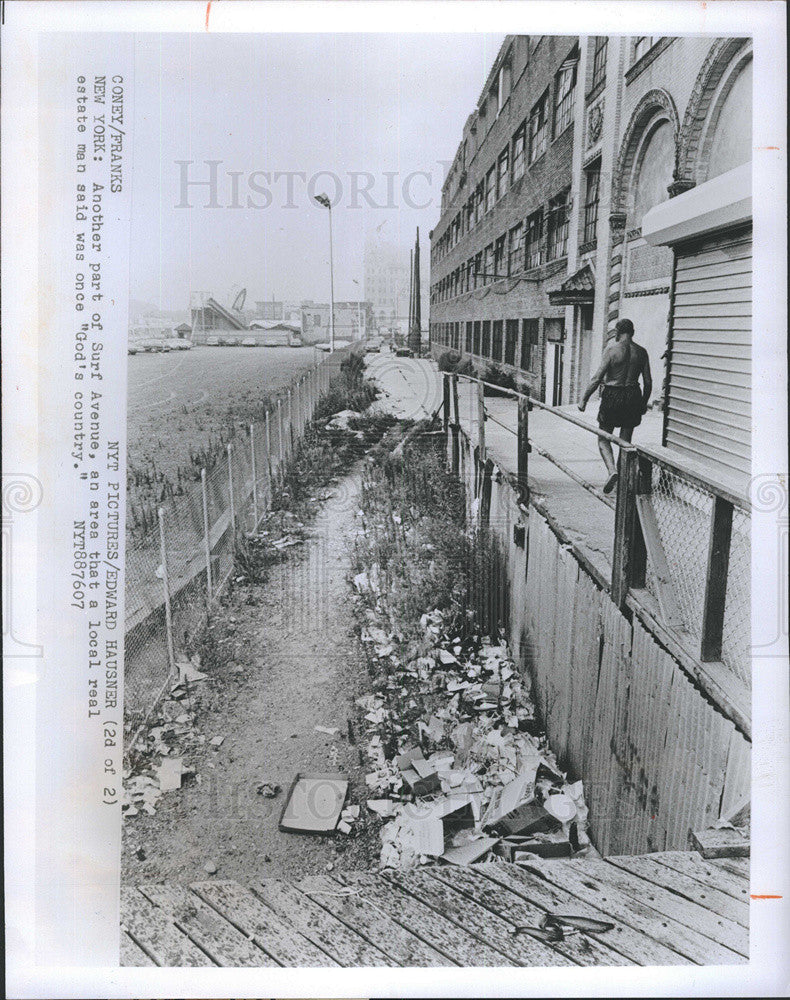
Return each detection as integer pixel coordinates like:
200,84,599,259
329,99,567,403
123,476,380,885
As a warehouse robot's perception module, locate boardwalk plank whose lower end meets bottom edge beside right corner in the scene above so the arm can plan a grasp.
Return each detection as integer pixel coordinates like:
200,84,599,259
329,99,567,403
527,861,744,965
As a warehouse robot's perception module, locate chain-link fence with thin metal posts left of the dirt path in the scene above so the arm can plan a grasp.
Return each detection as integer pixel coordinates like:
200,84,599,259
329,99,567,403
124,349,348,731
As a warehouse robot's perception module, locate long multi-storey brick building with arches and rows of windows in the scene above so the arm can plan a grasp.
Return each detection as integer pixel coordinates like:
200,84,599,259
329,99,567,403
430,36,752,488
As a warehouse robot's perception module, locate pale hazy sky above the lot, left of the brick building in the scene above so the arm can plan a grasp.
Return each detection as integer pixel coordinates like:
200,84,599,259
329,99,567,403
131,34,504,309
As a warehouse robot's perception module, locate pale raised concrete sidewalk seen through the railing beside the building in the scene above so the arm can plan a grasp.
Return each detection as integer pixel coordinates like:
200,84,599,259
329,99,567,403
368,356,661,579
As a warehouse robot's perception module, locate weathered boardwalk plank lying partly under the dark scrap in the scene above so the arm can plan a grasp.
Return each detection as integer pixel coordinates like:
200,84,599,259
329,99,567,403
427,865,633,965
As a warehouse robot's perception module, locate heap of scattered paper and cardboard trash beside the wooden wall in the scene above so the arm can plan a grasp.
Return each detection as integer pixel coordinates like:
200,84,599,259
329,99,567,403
356,604,595,869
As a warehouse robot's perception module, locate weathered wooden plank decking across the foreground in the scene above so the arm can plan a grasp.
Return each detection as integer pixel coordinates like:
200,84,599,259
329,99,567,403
121,851,749,968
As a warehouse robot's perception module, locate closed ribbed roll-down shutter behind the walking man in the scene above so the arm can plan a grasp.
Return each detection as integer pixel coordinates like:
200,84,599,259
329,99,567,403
665,225,752,483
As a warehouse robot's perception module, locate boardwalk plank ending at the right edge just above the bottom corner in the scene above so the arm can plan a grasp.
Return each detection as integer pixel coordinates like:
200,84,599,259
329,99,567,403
556,860,749,958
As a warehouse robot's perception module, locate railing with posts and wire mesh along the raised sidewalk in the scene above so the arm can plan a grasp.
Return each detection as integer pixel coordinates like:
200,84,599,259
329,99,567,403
443,374,751,714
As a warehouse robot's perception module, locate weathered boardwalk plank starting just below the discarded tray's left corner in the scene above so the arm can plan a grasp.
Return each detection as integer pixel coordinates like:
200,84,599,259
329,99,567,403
251,879,397,968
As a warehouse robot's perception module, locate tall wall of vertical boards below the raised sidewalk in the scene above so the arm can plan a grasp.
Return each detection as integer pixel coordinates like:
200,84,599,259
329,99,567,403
448,425,751,855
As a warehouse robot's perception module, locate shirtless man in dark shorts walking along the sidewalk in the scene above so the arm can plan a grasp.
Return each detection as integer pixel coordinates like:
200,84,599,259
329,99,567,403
579,319,653,493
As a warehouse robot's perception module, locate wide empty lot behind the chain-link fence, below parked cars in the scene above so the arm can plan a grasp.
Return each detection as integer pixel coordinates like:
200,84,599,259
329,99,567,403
127,347,322,516
